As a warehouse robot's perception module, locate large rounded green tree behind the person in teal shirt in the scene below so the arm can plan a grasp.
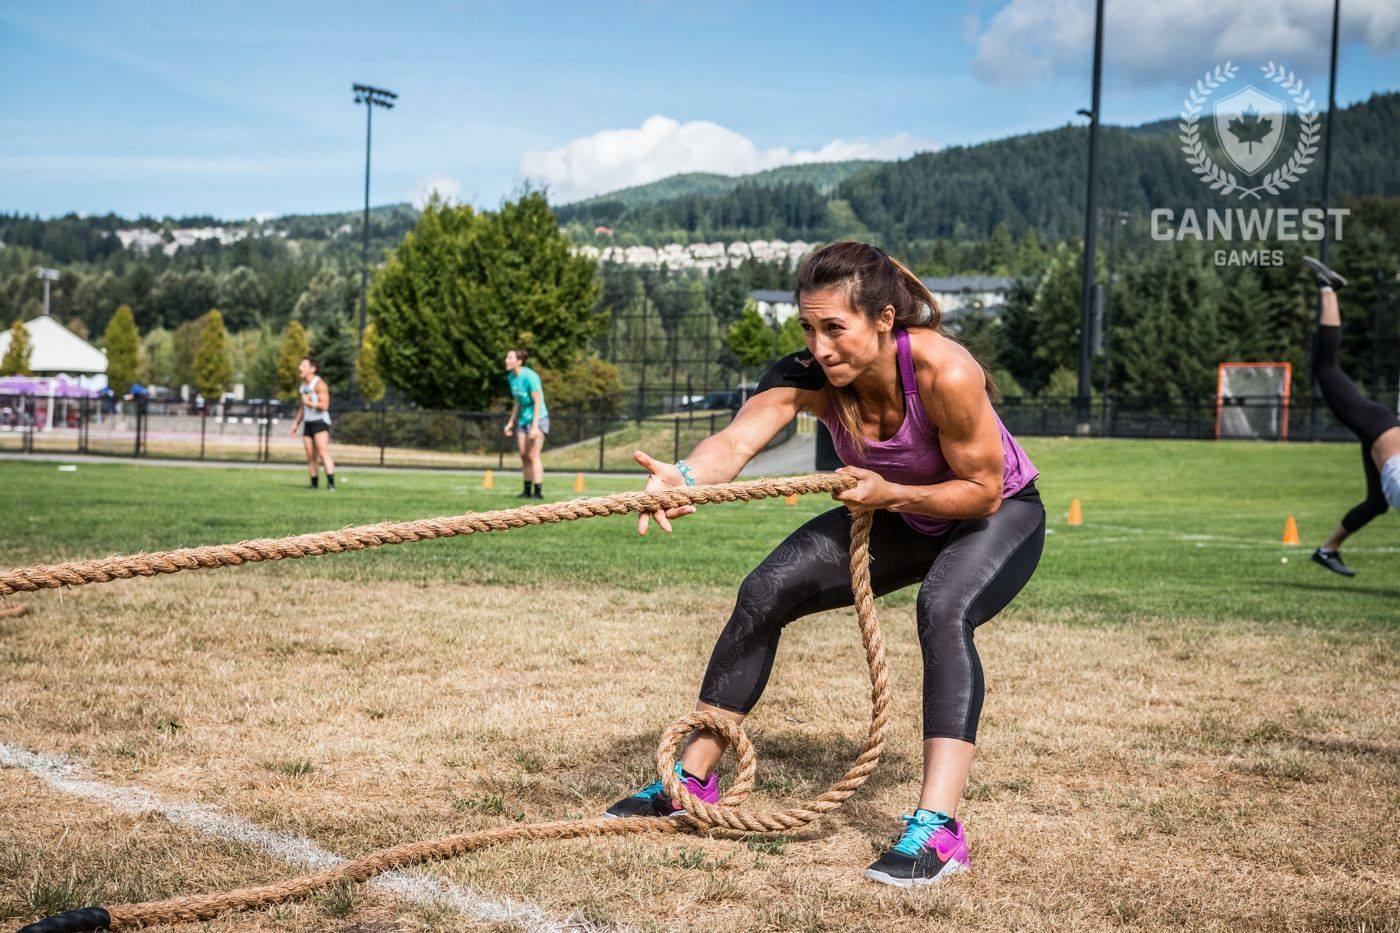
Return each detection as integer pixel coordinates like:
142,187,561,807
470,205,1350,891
370,192,606,409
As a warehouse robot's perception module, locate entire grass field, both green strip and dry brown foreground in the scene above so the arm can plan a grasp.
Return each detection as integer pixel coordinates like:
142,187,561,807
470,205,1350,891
0,438,1400,932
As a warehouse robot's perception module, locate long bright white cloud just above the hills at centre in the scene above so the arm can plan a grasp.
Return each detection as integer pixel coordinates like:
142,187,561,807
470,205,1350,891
519,115,937,202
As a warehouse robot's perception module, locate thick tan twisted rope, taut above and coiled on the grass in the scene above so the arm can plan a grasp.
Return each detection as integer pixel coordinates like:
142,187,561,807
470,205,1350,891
16,474,890,933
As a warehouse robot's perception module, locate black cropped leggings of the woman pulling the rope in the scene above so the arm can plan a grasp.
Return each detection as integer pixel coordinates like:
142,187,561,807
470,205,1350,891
700,483,1046,742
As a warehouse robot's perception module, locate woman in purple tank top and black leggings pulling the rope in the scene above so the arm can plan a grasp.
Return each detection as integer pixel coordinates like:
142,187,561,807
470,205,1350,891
608,242,1044,887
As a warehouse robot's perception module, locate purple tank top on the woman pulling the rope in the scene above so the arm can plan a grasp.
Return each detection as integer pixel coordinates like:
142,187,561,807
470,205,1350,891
822,328,1040,535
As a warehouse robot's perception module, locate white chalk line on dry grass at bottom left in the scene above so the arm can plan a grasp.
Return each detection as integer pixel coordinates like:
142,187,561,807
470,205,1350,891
0,742,580,933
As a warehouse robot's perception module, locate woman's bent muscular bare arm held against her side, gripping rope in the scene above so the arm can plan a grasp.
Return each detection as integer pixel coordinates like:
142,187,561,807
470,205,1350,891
889,347,1005,518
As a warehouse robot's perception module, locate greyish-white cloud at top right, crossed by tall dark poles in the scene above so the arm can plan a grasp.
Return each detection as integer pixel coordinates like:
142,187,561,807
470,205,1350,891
973,0,1400,85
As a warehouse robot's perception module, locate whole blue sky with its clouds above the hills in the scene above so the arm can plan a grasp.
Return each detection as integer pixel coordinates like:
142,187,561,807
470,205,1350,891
0,0,1400,217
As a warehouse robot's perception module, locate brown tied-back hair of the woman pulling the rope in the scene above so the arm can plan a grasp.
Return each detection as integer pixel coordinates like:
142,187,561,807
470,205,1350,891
797,241,998,455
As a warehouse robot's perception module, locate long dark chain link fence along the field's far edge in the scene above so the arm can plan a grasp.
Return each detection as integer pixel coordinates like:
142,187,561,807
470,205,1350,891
0,391,1377,472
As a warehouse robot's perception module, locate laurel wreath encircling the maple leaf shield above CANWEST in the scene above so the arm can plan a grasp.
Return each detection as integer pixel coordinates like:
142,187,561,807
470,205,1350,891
1177,62,1319,200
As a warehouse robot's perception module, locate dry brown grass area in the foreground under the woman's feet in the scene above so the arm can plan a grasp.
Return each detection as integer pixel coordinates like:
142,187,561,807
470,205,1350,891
0,570,1400,932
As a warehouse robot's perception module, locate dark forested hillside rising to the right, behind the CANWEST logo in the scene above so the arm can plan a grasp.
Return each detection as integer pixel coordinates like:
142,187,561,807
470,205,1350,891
559,92,1400,245
